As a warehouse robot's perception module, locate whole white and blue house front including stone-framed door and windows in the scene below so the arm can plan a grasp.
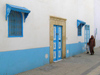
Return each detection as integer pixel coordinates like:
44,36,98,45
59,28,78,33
0,0,94,75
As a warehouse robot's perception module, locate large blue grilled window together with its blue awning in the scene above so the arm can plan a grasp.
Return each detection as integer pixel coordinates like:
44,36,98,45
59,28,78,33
5,4,30,37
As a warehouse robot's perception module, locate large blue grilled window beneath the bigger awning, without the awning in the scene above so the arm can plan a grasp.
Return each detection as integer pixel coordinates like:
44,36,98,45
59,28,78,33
8,11,23,37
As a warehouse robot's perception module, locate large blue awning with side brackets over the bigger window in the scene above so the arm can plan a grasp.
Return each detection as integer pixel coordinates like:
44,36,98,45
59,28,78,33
6,4,30,22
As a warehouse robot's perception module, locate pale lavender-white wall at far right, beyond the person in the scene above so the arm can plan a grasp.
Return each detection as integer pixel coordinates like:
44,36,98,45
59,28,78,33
94,0,100,47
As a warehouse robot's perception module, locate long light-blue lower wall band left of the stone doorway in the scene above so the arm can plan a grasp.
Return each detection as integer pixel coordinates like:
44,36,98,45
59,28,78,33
0,47,50,75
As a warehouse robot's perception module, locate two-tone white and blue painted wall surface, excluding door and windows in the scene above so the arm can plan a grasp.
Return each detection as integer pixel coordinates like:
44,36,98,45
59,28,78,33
0,0,94,75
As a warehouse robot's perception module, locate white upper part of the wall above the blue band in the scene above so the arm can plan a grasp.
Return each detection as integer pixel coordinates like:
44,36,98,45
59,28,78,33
0,0,94,51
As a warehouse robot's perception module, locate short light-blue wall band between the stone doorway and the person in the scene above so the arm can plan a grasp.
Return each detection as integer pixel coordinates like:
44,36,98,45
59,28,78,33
66,42,85,58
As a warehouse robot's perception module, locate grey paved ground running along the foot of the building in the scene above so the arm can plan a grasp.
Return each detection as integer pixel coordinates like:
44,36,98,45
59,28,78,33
17,48,100,75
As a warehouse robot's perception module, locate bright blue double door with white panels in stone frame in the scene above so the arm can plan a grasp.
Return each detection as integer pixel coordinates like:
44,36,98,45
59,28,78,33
53,25,62,61
